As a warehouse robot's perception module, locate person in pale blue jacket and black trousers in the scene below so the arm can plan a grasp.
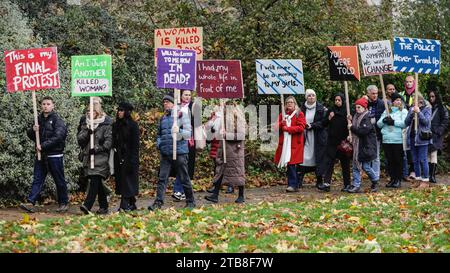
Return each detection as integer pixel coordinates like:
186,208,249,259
377,93,408,188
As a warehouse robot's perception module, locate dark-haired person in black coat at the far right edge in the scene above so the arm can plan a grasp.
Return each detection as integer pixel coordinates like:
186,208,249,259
428,88,448,183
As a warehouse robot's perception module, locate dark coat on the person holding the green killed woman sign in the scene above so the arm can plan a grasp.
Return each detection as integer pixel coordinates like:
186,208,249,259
77,116,113,178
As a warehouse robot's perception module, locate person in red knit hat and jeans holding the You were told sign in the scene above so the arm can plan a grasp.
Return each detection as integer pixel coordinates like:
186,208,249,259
347,98,380,193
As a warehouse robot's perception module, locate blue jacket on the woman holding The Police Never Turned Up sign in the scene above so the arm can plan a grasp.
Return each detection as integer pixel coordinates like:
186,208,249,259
405,106,432,148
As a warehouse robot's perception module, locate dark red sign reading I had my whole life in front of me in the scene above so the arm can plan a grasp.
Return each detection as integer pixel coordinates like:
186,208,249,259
197,60,244,98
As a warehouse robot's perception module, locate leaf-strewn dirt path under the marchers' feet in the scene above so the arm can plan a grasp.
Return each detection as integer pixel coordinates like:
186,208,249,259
0,175,450,221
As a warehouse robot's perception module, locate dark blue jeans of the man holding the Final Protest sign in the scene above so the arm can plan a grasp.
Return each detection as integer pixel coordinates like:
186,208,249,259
28,157,69,205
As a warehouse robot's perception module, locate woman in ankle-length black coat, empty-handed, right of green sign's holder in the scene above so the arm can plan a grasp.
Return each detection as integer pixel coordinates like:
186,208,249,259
113,102,140,211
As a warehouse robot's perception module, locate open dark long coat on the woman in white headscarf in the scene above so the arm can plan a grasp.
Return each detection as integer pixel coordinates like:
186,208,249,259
301,102,328,174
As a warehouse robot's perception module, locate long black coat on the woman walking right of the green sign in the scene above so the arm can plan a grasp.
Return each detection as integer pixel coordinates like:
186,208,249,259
113,119,139,197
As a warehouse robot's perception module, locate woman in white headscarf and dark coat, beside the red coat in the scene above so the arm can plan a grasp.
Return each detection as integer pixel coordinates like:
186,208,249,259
298,89,327,187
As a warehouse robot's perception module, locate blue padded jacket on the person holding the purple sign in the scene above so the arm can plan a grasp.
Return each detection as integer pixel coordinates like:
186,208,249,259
156,107,192,156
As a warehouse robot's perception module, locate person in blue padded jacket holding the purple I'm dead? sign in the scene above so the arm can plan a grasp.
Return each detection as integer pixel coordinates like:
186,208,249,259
148,93,195,211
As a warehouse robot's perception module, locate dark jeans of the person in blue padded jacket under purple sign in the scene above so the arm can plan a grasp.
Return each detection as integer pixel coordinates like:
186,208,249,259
155,154,195,204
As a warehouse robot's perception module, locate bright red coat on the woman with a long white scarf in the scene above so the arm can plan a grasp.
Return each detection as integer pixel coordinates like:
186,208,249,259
275,112,306,165
